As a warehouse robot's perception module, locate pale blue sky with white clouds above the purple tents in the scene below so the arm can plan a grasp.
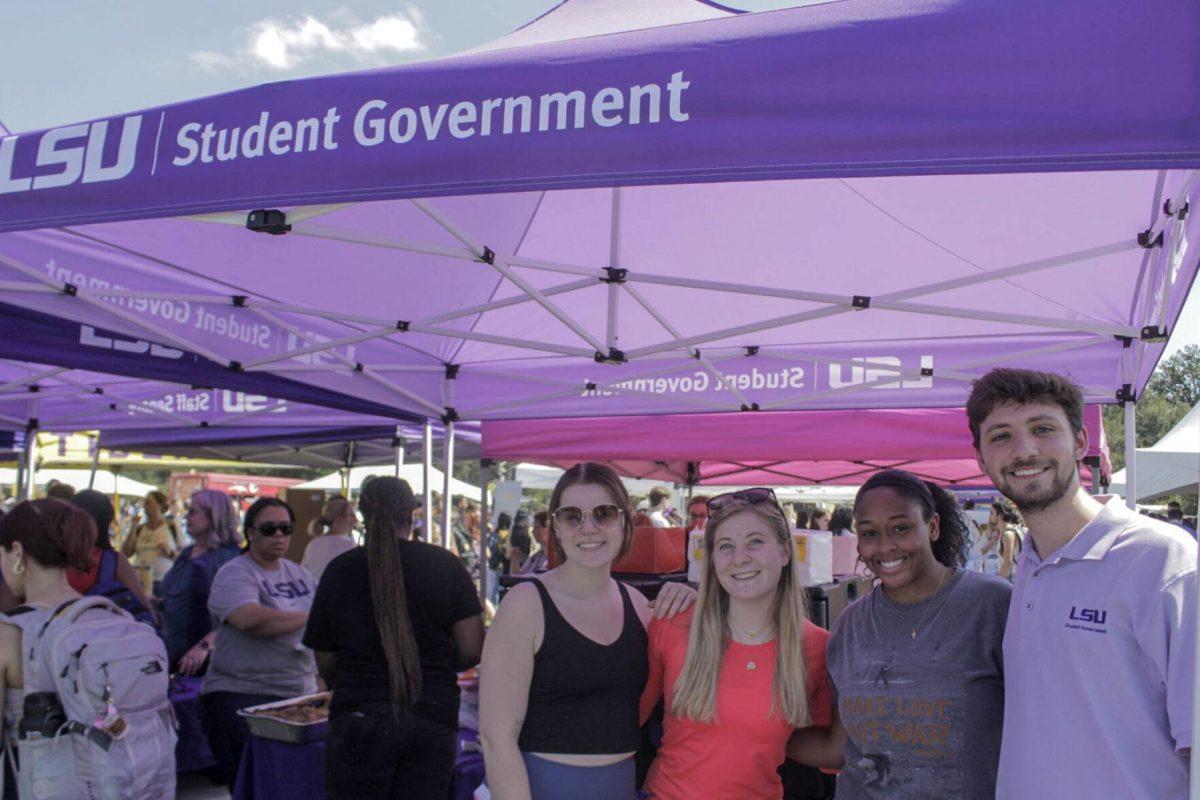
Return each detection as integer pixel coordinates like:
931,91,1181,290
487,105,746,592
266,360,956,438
0,0,1200,354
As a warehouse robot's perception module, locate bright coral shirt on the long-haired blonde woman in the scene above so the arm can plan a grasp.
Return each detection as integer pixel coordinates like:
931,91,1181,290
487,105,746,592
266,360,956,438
641,610,830,800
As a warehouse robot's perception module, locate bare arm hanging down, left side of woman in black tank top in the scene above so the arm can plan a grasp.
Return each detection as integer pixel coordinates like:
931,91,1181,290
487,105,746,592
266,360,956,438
479,583,544,800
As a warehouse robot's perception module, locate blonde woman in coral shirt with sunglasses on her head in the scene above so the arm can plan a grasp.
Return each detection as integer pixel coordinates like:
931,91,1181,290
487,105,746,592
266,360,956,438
641,488,830,800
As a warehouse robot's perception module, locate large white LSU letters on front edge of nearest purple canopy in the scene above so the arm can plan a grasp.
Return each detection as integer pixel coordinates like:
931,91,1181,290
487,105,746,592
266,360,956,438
0,114,142,194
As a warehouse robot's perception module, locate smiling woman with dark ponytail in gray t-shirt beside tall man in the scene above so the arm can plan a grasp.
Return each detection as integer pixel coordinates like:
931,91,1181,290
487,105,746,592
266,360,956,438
788,470,1012,800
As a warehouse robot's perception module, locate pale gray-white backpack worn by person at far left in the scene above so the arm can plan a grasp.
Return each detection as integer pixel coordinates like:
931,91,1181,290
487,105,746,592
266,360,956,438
12,596,175,800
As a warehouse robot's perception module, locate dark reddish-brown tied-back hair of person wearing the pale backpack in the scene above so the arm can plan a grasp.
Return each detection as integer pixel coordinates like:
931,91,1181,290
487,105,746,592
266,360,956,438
0,498,96,572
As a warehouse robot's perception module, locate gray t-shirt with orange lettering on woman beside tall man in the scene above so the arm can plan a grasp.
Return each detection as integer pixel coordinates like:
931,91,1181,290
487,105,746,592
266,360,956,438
827,570,1012,800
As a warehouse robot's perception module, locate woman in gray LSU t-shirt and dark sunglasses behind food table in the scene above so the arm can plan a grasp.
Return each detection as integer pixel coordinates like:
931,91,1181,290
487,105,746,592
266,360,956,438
200,498,317,789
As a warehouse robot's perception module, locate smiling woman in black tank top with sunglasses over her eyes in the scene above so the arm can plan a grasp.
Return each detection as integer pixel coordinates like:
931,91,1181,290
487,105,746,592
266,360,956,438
480,463,694,800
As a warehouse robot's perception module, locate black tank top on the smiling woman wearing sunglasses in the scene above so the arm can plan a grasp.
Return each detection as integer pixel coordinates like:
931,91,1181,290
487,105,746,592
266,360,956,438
517,581,649,756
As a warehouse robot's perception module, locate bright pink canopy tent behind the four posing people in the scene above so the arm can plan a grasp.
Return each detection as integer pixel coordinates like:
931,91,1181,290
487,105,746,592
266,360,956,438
484,405,1112,487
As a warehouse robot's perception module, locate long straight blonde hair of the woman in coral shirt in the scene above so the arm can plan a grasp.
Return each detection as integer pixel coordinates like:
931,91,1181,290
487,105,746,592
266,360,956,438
671,500,811,728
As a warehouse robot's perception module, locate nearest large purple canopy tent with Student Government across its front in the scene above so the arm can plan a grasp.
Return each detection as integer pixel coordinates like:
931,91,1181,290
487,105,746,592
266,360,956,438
0,0,1200,638
